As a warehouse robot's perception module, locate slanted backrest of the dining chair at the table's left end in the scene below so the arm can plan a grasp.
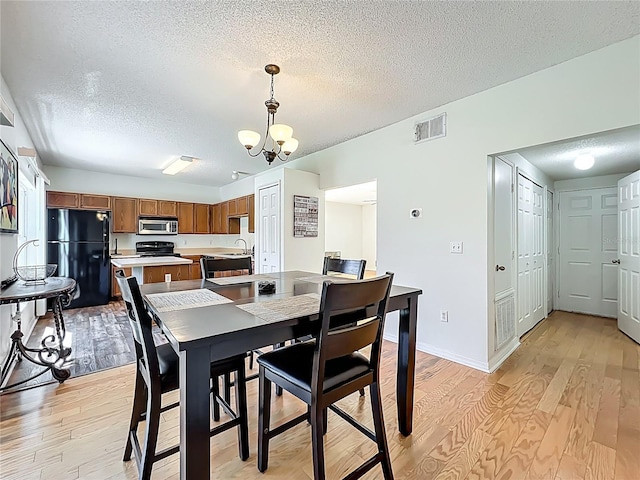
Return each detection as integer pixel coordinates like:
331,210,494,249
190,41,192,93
116,270,160,387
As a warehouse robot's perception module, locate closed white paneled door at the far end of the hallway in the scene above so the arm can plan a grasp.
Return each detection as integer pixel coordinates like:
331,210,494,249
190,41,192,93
558,187,618,318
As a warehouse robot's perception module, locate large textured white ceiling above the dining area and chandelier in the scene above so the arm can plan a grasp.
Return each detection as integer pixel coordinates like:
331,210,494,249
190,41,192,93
0,0,640,186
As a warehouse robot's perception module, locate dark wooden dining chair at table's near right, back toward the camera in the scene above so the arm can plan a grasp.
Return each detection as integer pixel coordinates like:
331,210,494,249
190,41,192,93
258,273,393,480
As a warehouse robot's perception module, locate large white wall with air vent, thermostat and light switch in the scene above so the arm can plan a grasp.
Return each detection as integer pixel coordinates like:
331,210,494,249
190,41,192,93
288,37,640,369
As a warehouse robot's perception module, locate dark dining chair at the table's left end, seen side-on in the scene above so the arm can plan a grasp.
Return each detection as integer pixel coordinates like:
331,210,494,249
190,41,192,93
115,270,249,480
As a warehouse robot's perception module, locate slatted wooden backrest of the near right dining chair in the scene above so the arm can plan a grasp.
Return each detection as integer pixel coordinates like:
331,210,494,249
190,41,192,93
312,272,393,394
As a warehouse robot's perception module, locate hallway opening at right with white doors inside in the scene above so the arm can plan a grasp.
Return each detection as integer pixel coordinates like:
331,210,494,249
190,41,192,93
489,125,640,352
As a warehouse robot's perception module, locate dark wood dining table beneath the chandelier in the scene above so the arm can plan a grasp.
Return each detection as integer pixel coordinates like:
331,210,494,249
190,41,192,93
141,271,422,480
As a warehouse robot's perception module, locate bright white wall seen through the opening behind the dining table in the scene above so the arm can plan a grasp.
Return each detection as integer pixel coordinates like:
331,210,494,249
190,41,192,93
324,202,363,259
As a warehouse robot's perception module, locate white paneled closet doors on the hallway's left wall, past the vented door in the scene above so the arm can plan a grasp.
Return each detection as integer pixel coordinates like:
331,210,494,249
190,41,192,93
518,174,546,336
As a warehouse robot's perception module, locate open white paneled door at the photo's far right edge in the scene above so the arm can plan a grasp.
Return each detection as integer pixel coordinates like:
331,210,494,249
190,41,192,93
618,170,640,343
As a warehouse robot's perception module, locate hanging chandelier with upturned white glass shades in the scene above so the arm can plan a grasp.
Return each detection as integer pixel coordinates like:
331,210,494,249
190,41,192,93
238,64,298,165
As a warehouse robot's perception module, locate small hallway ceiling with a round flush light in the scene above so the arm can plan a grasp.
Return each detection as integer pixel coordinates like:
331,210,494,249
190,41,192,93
518,125,640,180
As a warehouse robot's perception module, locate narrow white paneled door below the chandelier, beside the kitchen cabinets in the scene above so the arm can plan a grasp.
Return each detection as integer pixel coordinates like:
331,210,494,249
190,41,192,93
257,185,281,273
